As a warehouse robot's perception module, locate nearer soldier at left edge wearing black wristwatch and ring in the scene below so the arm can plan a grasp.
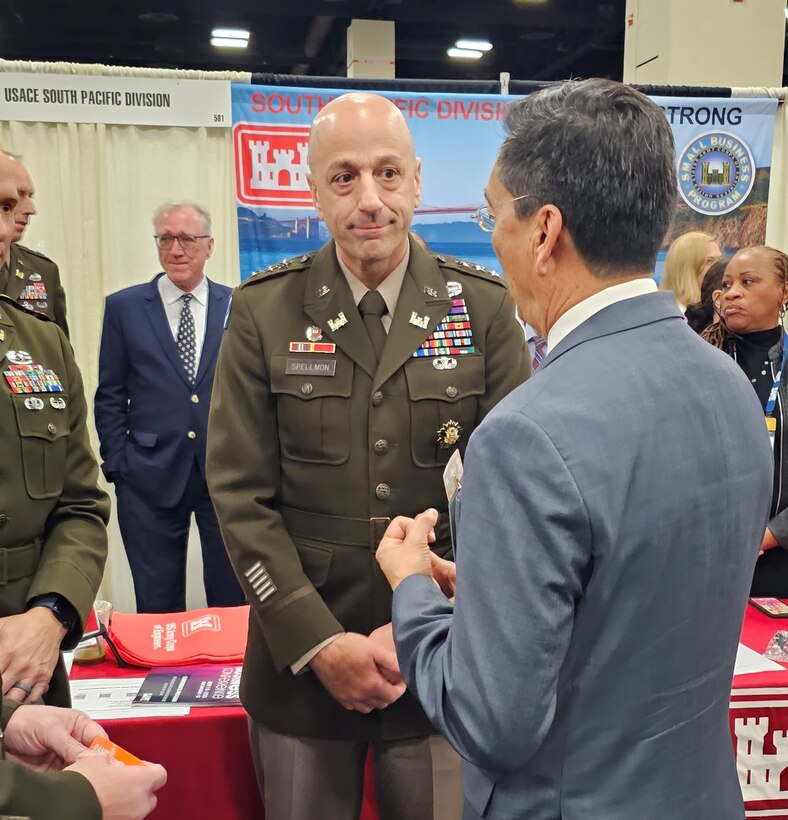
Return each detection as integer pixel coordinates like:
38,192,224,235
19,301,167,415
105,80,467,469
0,176,109,706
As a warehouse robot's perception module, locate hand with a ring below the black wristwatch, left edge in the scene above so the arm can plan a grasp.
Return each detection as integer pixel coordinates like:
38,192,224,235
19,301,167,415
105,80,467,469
0,606,66,703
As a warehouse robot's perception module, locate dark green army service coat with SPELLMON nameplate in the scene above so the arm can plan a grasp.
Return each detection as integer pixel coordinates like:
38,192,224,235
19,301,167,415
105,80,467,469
208,242,529,740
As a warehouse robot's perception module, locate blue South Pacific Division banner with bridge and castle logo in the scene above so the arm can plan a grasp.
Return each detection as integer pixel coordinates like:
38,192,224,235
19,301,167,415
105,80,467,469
231,84,777,279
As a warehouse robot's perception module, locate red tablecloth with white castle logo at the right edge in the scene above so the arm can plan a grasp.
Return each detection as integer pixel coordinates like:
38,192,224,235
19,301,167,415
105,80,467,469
730,606,788,820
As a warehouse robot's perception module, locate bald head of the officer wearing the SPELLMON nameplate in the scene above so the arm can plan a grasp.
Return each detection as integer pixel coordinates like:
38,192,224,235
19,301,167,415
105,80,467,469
309,93,421,289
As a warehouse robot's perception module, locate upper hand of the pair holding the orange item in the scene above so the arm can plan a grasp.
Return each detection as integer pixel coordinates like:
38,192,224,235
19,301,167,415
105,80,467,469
5,706,107,772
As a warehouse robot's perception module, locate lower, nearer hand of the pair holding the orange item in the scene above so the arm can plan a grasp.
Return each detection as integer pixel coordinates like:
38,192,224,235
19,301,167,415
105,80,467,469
66,752,167,820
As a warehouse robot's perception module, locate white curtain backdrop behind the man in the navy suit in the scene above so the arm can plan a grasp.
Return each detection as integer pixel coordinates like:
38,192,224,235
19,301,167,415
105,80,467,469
0,60,788,612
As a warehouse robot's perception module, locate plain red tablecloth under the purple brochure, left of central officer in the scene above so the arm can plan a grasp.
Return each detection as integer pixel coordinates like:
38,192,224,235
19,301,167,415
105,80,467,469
71,655,377,820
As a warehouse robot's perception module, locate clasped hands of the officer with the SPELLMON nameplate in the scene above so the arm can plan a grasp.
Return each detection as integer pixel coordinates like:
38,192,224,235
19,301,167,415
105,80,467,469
309,632,405,714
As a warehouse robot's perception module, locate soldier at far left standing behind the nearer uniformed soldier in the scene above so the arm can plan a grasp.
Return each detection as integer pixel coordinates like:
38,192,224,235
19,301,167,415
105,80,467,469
0,148,68,336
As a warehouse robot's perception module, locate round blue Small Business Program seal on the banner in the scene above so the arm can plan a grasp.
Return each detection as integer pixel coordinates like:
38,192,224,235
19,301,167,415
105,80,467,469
678,131,755,216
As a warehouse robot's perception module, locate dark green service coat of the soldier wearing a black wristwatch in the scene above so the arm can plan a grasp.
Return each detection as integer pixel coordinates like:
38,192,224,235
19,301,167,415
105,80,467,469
0,296,109,706
